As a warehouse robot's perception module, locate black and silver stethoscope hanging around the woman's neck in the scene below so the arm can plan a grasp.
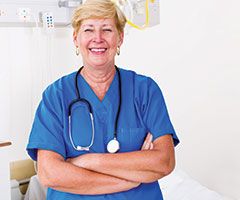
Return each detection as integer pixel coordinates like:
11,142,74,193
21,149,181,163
68,66,122,153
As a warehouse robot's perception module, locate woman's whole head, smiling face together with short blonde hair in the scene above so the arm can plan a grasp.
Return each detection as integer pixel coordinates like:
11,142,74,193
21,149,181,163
72,1,126,73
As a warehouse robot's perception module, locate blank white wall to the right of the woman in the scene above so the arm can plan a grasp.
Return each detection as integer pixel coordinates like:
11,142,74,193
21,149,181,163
117,0,240,199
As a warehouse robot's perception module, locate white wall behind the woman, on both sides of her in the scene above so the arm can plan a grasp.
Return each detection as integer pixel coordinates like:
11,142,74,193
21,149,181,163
0,0,240,199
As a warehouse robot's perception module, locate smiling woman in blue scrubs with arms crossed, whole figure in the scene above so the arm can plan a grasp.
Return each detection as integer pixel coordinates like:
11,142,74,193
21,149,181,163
27,0,179,200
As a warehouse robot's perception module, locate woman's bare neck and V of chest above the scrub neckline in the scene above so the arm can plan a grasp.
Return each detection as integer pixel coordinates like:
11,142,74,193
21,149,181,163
81,67,116,101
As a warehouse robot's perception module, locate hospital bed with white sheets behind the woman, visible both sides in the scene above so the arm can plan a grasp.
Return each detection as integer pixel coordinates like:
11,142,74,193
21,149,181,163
11,161,235,200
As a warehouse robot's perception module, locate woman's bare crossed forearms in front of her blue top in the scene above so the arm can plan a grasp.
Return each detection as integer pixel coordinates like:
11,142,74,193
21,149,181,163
38,133,175,195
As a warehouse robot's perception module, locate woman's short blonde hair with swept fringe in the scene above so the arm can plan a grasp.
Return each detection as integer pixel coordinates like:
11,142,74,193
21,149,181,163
72,0,127,33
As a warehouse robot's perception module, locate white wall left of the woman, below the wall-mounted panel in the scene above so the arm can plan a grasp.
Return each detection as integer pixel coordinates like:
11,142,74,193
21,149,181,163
0,27,79,160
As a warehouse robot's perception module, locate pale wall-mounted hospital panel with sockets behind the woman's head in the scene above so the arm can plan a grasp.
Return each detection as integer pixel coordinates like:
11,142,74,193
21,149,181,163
0,0,160,30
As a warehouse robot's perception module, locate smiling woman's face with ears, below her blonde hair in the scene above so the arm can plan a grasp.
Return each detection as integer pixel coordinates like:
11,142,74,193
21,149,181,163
73,19,123,68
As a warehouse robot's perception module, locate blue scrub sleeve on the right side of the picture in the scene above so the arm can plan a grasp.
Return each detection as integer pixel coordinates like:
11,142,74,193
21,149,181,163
142,78,179,146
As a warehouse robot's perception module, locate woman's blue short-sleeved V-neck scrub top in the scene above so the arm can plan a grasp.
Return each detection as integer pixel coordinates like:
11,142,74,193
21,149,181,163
27,69,179,200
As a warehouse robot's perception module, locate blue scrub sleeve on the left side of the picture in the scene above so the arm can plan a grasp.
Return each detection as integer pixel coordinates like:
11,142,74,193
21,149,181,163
27,86,66,160
